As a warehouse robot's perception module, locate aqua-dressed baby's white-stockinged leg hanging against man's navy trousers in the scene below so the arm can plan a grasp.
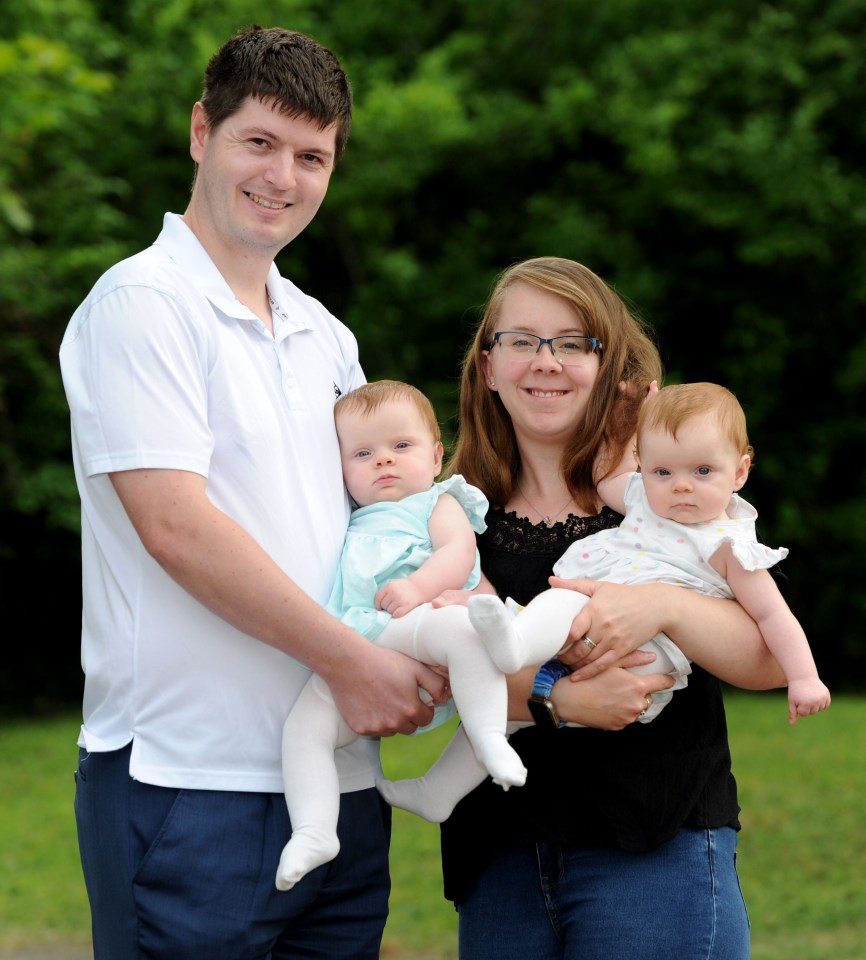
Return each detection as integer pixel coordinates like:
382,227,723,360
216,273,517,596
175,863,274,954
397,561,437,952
276,676,357,890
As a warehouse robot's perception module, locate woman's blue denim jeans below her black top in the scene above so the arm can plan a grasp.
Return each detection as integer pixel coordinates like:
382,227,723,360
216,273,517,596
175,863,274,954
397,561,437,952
458,827,749,960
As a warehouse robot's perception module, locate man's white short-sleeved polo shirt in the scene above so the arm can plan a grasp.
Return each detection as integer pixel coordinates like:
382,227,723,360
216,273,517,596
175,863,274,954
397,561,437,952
60,214,378,792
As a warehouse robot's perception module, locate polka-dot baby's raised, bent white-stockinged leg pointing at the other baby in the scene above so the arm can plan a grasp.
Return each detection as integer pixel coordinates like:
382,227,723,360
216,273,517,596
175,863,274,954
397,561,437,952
469,588,589,673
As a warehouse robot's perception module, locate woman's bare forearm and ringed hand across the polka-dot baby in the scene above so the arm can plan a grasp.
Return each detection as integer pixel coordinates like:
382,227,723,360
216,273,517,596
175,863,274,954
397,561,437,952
550,577,785,690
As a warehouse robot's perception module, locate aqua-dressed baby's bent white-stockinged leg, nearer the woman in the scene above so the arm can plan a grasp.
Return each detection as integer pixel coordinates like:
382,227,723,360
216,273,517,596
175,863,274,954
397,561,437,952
384,604,526,790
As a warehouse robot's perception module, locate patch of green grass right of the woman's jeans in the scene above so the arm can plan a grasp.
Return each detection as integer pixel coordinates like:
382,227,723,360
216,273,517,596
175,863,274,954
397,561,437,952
727,693,866,960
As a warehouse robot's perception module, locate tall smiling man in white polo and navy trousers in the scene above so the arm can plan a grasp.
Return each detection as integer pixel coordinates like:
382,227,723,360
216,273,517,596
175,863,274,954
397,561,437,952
60,27,444,960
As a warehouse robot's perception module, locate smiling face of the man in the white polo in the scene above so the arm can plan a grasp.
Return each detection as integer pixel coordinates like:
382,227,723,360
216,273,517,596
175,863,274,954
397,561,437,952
186,98,336,260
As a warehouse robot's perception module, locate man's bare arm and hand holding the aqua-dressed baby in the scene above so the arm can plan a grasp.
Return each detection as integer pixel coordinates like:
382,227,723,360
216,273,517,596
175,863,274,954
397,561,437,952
111,470,445,736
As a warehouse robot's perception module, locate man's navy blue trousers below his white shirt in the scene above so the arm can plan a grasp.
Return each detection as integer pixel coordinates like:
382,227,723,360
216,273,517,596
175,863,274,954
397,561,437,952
75,747,391,960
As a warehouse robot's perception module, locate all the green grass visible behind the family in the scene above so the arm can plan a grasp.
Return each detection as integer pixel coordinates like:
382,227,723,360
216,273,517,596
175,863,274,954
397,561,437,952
0,693,866,960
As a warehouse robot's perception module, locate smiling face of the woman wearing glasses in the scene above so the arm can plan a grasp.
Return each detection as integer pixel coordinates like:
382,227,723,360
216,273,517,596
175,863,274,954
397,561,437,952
483,283,599,447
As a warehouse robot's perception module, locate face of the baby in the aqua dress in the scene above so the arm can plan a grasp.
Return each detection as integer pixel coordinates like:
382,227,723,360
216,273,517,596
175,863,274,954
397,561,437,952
336,400,442,507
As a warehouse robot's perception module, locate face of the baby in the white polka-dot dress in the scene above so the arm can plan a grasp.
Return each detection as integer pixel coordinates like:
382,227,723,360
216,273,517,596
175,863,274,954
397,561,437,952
640,414,750,523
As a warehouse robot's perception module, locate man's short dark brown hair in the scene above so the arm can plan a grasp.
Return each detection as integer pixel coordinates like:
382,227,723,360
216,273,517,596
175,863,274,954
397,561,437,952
201,24,352,160
